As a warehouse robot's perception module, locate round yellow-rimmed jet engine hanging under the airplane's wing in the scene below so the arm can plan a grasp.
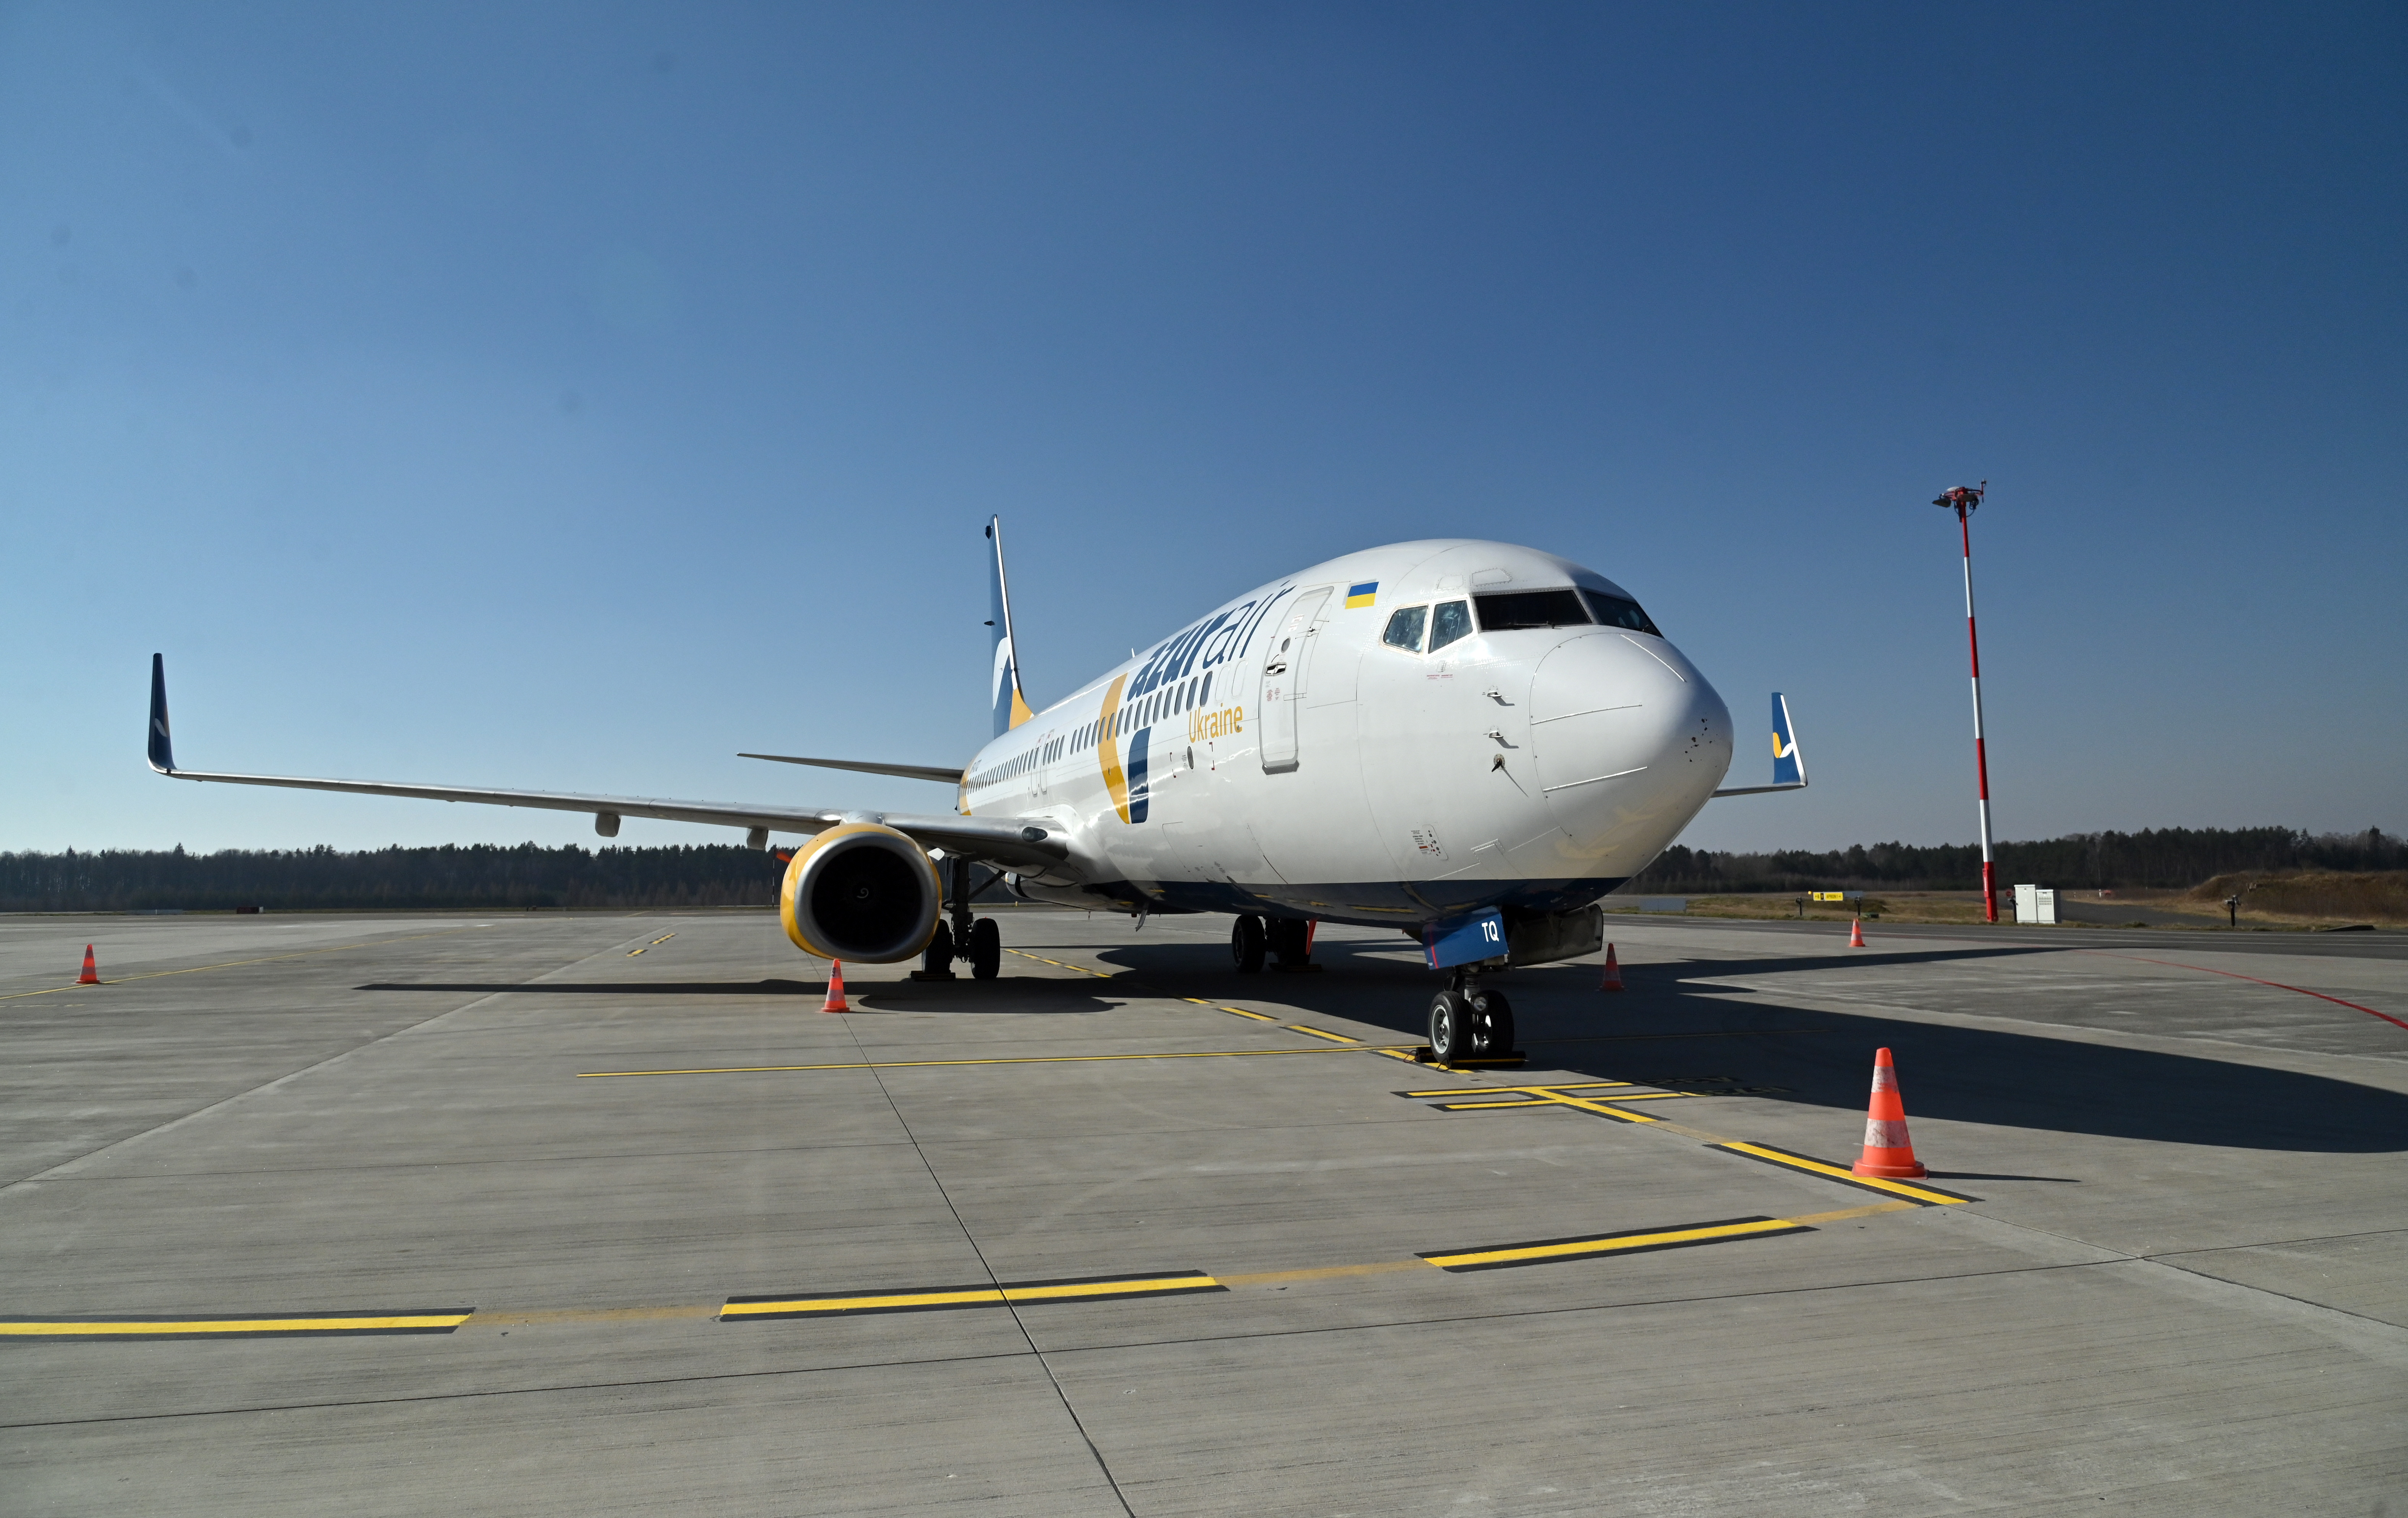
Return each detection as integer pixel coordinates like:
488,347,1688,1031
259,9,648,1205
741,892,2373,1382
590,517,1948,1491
778,822,944,964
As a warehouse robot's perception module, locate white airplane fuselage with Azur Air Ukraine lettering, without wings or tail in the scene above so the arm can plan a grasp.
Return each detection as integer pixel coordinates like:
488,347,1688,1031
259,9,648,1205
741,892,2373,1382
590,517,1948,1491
961,540,1731,928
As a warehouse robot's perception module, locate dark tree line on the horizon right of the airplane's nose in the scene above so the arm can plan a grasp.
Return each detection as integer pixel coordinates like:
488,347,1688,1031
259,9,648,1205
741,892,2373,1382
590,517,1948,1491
1623,826,2408,896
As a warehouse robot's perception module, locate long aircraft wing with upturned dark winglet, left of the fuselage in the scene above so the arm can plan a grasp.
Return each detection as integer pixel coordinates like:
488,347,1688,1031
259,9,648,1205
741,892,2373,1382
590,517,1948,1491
149,653,1069,870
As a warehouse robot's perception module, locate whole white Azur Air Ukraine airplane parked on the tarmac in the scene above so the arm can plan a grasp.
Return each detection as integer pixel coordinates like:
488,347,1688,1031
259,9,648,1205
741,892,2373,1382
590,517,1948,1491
149,518,1806,1063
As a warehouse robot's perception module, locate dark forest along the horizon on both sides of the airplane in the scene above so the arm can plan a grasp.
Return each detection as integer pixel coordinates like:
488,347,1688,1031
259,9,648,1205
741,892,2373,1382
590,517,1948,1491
0,826,2408,911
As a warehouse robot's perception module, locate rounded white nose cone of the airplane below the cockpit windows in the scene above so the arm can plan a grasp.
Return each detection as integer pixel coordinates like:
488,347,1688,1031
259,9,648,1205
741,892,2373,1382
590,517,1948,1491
1529,631,1731,867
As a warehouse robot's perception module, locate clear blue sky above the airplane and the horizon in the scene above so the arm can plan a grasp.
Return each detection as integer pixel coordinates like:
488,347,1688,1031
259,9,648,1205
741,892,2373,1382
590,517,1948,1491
0,0,2408,848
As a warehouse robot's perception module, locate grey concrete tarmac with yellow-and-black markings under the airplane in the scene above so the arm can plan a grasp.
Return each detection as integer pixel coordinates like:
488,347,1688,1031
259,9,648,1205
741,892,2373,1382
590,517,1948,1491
0,911,2408,1518
